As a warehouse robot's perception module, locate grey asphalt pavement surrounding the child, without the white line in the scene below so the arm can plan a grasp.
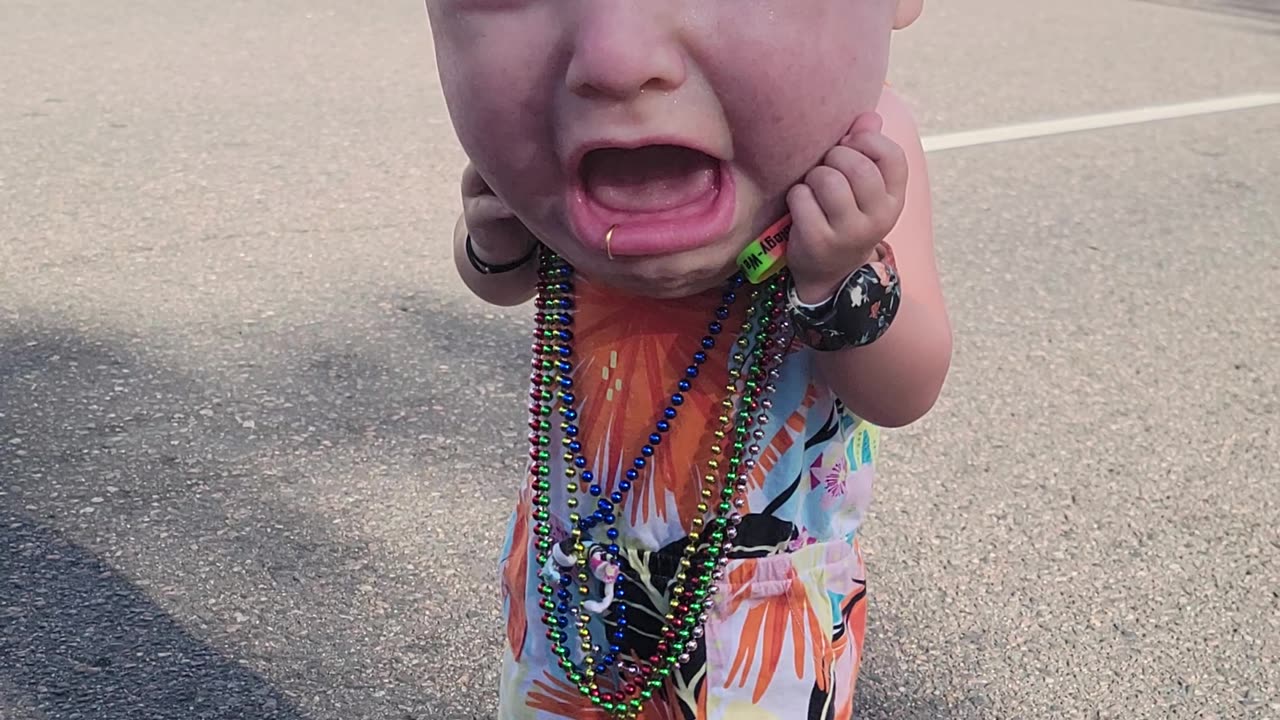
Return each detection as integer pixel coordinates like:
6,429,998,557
0,0,1280,720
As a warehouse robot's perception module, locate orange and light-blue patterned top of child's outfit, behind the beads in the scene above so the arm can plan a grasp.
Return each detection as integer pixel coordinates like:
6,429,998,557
527,271,879,551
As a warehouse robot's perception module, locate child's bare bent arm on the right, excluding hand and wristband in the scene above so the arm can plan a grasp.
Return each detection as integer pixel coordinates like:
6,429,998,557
815,91,952,427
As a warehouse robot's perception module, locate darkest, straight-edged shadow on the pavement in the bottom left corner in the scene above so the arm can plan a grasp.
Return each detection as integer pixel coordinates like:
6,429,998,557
0,510,303,720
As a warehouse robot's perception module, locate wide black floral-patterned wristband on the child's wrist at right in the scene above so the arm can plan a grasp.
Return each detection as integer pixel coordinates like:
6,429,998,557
787,246,902,352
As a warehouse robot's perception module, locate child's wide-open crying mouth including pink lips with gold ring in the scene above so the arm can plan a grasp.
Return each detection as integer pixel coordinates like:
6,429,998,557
568,143,735,256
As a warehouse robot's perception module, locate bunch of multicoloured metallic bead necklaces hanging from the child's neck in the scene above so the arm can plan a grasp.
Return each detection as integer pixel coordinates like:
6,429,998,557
530,251,788,719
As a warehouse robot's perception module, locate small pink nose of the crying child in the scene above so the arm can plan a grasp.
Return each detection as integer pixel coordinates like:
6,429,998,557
566,0,687,100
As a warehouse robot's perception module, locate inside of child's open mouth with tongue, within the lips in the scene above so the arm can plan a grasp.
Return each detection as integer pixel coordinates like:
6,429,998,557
582,145,718,213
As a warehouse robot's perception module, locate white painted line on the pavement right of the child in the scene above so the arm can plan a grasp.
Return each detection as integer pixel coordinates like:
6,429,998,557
923,92,1280,152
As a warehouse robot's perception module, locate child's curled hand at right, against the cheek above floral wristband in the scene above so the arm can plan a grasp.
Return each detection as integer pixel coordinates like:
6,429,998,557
787,113,908,302
